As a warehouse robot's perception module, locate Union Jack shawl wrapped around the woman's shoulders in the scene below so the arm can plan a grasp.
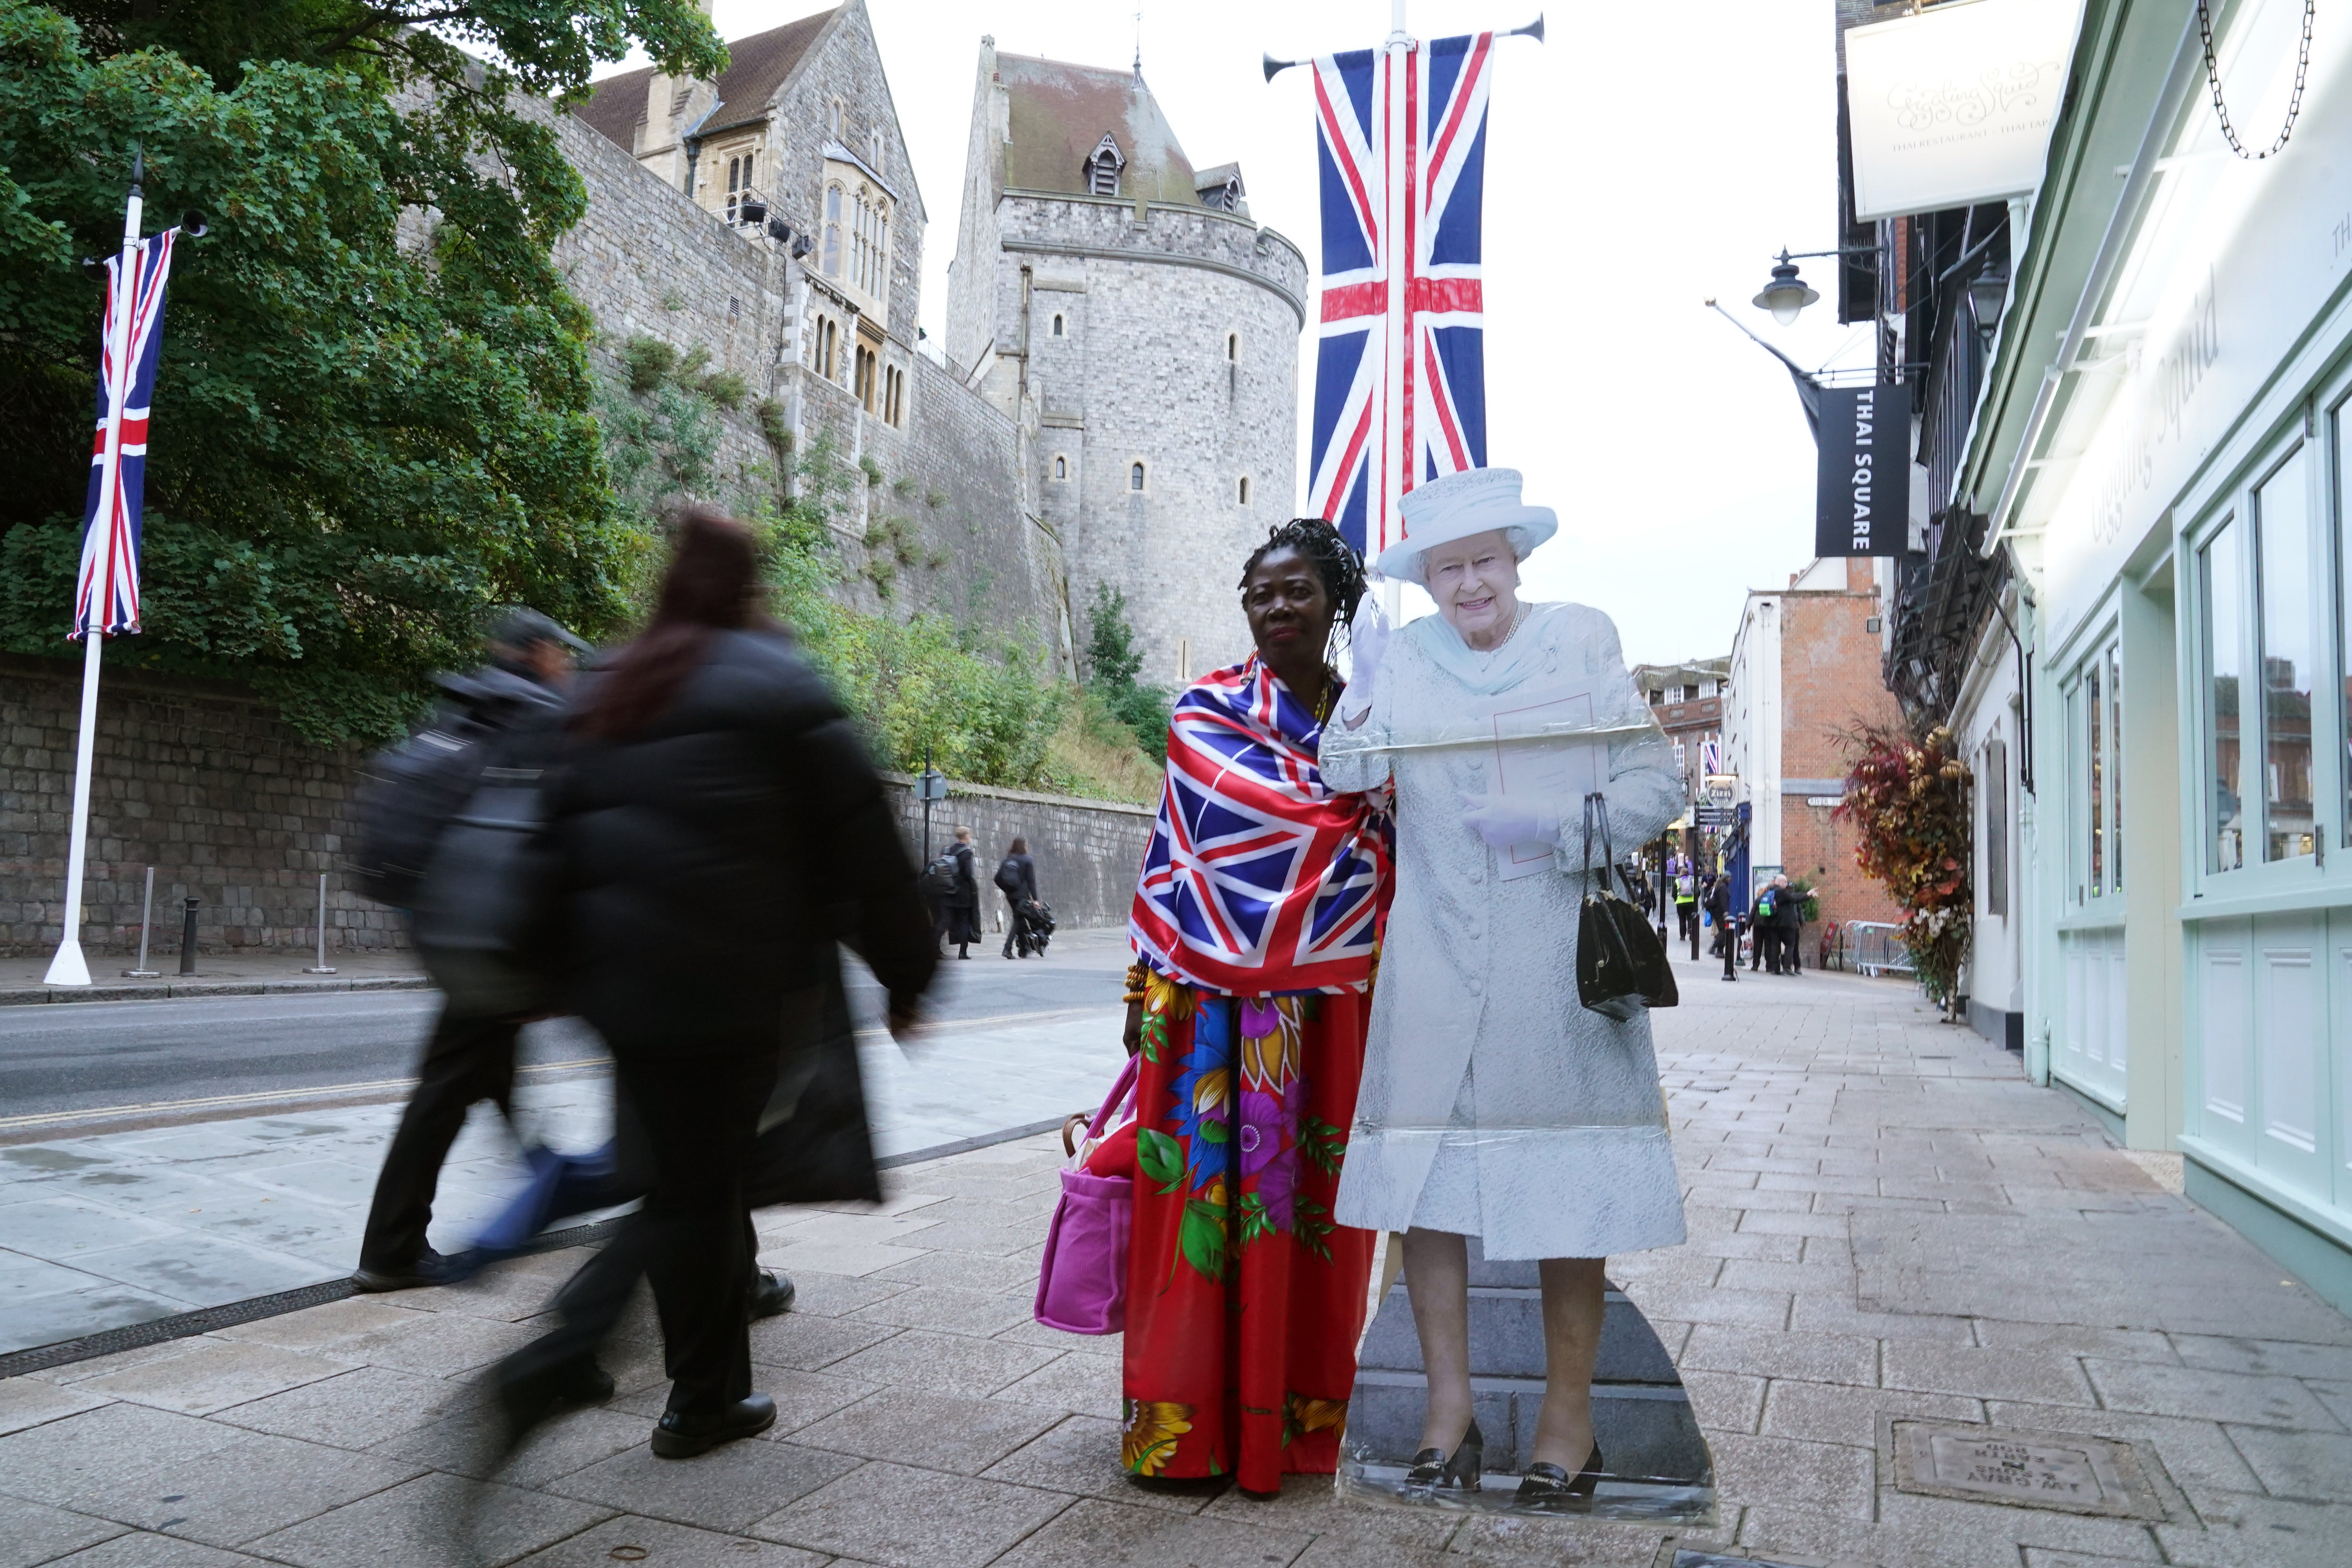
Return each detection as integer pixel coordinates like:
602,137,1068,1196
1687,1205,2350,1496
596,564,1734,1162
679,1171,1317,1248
1127,653,1390,997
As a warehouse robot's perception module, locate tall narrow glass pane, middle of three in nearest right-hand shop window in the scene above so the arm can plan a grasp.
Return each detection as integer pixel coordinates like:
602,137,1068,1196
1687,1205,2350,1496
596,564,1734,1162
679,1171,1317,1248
2253,446,2319,860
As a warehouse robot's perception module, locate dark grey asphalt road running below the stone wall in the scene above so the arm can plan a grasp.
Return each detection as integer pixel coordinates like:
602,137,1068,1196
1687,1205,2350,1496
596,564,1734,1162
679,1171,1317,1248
0,931,1127,1124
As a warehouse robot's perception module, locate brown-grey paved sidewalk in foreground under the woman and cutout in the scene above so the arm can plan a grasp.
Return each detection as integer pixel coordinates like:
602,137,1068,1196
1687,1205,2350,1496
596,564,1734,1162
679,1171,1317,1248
0,949,2352,1568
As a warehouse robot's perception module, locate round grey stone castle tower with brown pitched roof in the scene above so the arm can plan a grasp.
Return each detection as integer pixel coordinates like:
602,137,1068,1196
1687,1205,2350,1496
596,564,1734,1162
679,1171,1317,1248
946,38,1308,684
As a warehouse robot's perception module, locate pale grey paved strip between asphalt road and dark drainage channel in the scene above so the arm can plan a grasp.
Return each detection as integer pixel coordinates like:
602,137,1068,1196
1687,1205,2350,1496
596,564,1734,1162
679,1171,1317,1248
0,1006,1122,1363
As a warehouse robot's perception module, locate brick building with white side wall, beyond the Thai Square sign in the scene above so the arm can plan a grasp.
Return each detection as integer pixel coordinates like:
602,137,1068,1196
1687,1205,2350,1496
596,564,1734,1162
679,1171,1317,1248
1724,557,1903,962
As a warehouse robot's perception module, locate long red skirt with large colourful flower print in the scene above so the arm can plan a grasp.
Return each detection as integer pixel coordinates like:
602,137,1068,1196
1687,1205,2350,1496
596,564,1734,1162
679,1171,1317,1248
1122,976,1374,1493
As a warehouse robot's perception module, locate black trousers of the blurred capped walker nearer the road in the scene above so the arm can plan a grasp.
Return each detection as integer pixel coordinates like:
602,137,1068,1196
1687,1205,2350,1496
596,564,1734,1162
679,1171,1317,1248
360,1002,522,1272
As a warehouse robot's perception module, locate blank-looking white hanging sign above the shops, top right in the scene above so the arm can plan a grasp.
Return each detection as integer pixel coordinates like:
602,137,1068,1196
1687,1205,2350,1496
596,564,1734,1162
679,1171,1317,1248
1846,0,2079,223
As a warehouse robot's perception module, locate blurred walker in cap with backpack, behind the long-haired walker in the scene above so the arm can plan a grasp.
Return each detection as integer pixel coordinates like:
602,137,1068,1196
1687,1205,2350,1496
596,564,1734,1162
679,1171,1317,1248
353,606,588,1290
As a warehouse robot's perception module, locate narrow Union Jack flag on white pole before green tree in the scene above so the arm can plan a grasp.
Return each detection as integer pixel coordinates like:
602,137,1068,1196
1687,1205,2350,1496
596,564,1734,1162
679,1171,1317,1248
66,228,179,639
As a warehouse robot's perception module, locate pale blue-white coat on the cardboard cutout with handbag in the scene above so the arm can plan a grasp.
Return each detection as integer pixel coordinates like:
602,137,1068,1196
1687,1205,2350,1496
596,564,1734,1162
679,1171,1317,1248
1322,604,1684,1260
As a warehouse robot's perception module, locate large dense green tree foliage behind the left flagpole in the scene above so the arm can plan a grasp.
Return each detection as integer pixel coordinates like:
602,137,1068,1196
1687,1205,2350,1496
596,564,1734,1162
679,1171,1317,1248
0,0,724,740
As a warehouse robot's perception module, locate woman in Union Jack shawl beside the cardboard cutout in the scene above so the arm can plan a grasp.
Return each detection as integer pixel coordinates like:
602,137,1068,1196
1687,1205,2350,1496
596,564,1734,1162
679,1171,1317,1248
1122,519,1390,1493
